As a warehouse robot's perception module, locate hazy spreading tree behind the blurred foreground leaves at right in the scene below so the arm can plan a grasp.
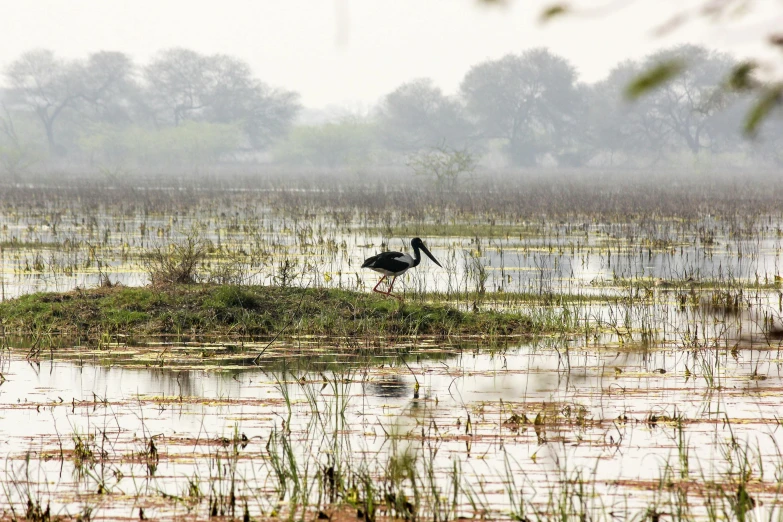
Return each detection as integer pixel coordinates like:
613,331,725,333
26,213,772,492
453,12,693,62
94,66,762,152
590,49,748,162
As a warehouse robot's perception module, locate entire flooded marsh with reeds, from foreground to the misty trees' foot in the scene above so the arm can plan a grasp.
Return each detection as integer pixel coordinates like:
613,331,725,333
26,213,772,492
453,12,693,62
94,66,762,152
0,169,783,522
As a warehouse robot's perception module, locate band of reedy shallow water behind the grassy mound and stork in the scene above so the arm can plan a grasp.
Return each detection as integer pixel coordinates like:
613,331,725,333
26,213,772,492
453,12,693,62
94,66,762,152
0,205,783,298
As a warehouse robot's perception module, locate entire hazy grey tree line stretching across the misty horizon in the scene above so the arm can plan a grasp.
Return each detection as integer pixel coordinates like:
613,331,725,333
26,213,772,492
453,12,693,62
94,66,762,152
0,45,783,174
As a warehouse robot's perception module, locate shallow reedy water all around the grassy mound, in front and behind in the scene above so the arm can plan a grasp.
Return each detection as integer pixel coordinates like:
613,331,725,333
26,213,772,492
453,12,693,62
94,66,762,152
0,193,783,521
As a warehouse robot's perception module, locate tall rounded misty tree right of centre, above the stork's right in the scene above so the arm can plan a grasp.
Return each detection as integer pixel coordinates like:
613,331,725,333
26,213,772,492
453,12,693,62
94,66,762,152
460,49,582,165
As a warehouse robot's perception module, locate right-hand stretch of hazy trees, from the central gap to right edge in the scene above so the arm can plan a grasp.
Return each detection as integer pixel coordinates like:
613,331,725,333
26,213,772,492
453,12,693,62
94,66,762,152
378,45,783,166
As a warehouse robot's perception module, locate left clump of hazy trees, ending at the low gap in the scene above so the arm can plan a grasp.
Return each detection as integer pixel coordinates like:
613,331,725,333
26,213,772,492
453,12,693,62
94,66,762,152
0,48,300,170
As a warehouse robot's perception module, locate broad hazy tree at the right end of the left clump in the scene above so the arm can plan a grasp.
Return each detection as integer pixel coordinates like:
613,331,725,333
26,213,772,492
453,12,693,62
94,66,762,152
144,48,300,148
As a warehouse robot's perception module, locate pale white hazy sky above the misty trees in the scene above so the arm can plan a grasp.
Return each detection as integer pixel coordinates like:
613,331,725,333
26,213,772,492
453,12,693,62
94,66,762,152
0,0,783,107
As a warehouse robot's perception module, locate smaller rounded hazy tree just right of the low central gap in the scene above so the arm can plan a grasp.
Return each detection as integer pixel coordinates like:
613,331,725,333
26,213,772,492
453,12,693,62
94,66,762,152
378,78,474,152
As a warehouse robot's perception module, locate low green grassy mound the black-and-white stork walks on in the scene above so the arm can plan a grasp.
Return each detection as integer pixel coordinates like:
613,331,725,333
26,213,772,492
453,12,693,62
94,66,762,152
0,285,533,338
